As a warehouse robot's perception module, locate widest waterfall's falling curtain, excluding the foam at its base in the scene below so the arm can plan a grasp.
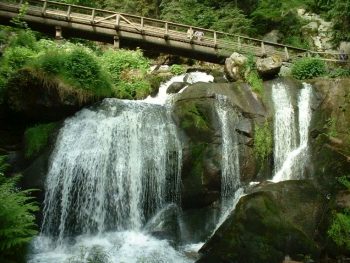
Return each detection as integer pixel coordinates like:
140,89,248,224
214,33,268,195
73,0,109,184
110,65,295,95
42,99,182,240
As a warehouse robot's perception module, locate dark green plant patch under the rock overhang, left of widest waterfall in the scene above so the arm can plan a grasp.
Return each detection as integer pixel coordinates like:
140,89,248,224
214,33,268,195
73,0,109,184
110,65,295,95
24,123,57,158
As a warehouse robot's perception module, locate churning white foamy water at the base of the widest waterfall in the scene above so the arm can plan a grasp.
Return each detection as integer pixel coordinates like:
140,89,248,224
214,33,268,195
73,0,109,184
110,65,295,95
28,231,196,263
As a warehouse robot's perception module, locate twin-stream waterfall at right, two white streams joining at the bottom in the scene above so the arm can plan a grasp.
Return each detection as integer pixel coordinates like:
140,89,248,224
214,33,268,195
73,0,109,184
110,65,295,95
272,83,312,182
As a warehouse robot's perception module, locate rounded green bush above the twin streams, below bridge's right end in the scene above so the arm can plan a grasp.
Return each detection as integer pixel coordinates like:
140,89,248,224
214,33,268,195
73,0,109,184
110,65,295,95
292,58,326,80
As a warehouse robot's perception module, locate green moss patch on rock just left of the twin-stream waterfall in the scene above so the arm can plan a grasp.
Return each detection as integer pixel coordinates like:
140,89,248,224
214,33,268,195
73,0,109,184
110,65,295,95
254,121,273,162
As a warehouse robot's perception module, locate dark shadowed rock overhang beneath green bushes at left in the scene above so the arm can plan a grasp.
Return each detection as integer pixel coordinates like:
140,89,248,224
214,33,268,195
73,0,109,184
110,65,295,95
7,69,94,122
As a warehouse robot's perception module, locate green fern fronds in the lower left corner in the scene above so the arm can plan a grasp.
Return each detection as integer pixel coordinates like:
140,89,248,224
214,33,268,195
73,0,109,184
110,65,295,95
0,156,39,262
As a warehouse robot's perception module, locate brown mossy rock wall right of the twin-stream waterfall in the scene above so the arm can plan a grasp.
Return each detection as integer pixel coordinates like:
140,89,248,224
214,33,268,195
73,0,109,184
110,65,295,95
310,79,350,191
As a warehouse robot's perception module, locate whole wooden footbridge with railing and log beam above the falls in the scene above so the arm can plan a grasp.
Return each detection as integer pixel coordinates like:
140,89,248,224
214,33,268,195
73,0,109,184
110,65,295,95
0,0,346,63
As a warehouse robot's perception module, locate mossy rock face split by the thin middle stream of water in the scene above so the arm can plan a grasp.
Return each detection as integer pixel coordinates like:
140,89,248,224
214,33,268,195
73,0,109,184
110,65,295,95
173,83,266,208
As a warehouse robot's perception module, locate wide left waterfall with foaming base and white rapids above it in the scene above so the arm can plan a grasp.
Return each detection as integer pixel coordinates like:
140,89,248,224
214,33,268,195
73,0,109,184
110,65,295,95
29,73,212,263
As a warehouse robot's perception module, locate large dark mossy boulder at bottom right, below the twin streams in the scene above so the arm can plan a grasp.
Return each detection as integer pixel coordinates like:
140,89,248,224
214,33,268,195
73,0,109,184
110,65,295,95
197,181,323,263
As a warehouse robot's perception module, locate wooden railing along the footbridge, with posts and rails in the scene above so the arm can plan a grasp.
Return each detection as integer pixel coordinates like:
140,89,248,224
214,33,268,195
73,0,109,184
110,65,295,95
2,0,348,61
